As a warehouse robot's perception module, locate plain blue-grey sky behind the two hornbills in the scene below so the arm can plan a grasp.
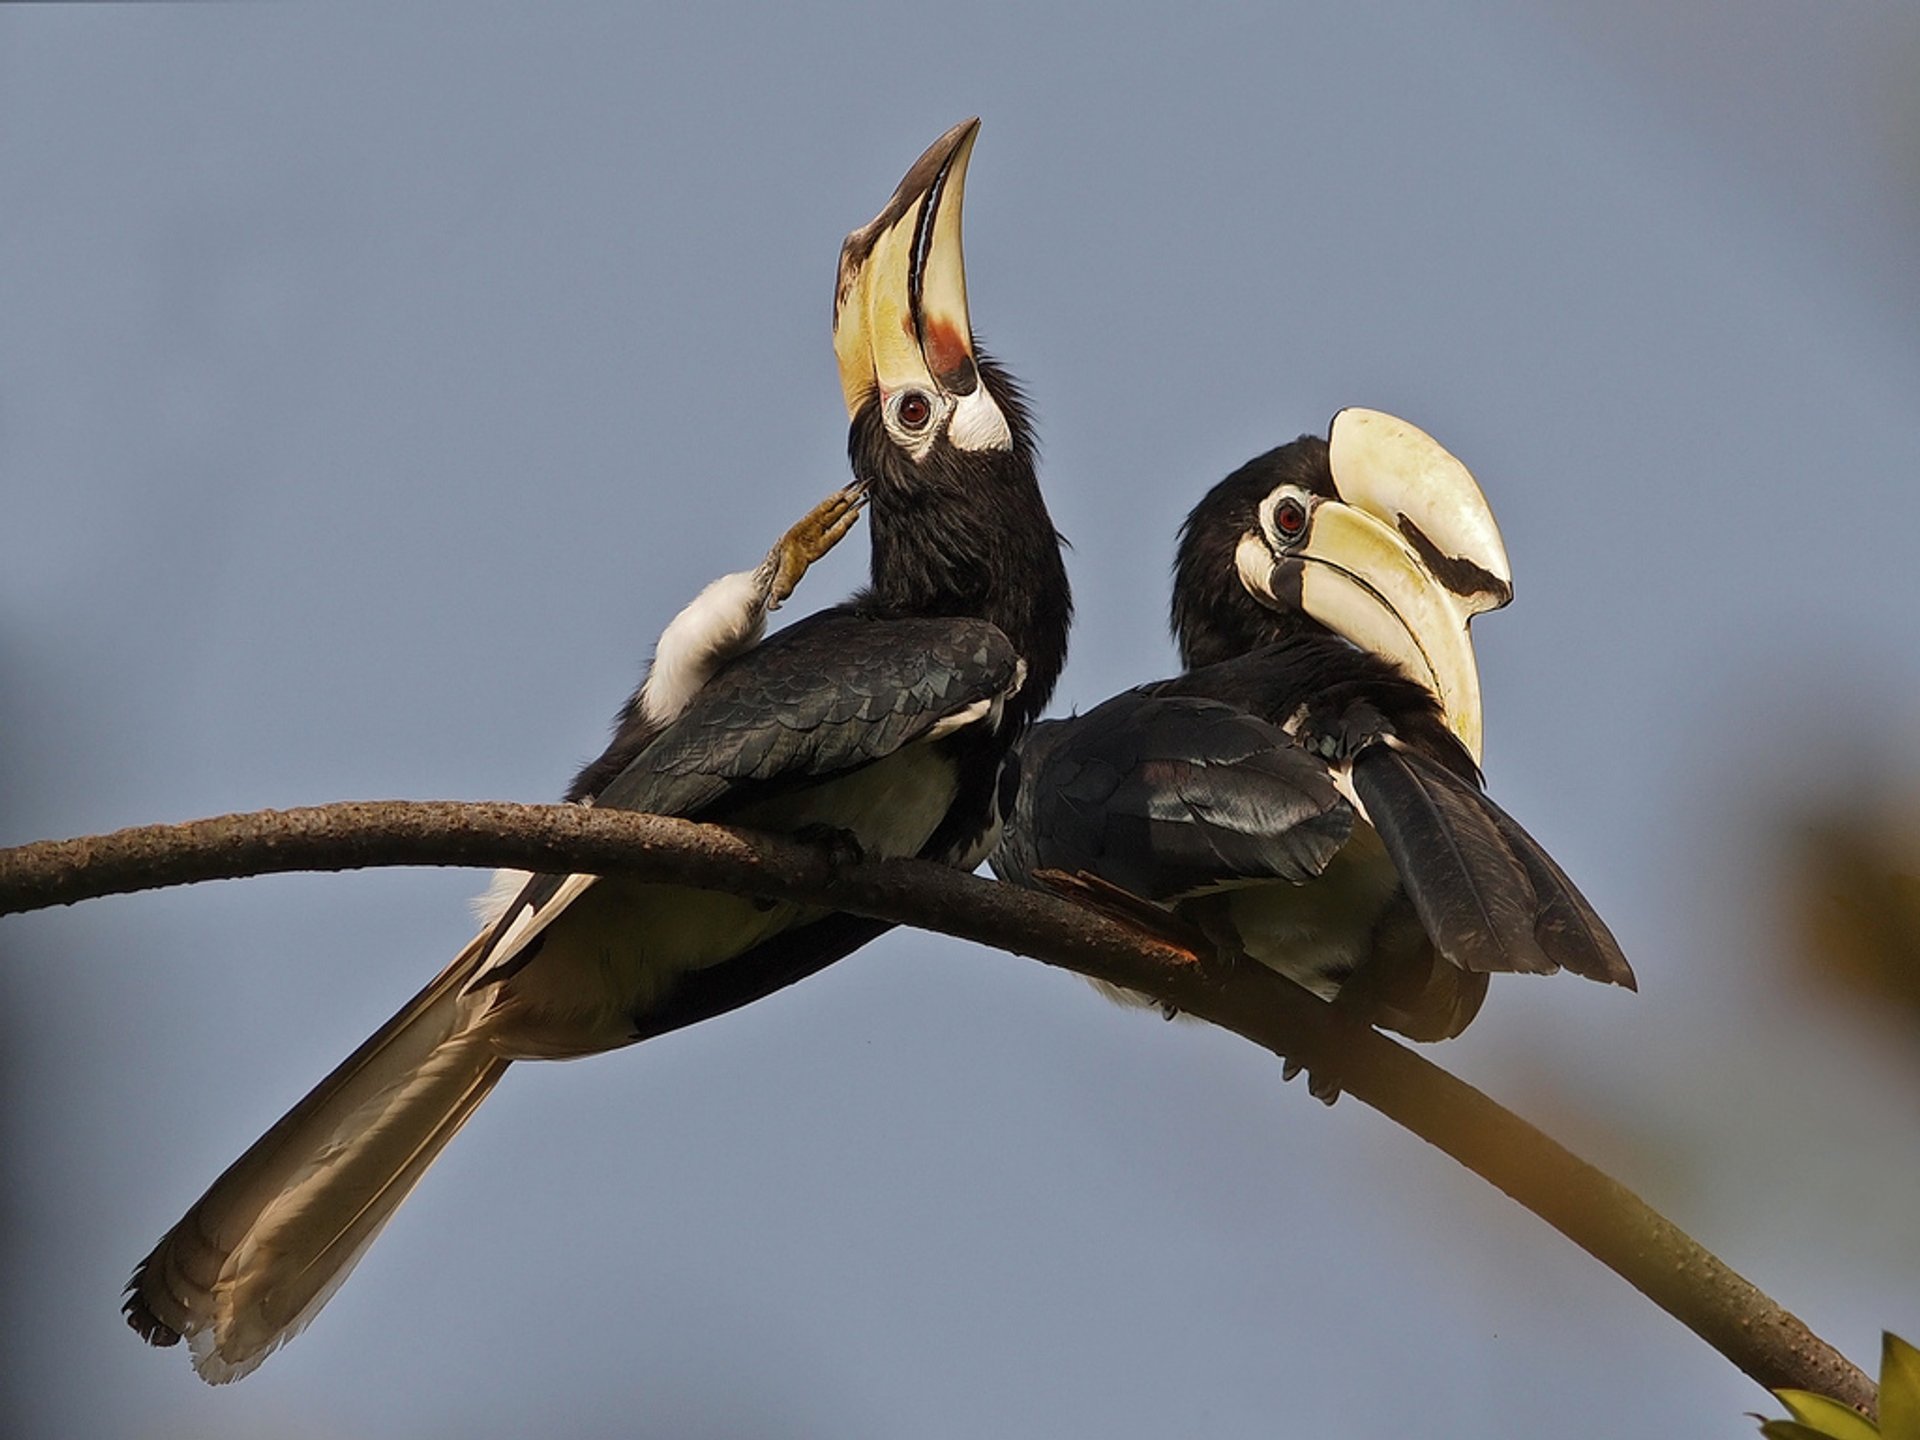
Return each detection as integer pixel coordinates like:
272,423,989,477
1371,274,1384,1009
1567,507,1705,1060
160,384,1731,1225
0,0,1920,1440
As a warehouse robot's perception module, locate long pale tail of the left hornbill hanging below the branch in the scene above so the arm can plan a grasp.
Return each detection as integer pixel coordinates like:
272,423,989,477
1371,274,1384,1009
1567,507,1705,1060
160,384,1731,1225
125,941,507,1384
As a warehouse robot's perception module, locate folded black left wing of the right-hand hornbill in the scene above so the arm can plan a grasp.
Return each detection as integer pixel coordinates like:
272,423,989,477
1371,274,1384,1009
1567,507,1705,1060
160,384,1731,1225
993,691,1354,900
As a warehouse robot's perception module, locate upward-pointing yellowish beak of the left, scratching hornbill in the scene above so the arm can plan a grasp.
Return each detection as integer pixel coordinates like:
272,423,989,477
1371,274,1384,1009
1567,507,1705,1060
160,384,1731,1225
833,119,979,417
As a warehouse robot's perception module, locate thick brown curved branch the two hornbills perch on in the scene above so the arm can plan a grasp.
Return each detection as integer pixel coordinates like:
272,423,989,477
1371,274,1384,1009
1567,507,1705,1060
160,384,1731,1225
0,801,1876,1413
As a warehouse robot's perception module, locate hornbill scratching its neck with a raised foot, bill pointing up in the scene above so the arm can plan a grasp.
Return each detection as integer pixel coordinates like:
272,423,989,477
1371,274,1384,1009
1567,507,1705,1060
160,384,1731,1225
125,121,1071,1382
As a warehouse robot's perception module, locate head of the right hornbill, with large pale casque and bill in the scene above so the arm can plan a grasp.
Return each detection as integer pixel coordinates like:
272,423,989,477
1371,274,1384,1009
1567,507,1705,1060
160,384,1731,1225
1173,409,1513,762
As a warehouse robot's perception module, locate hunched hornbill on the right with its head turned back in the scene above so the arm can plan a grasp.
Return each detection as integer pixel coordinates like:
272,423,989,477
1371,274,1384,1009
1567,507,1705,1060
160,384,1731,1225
995,409,1634,1075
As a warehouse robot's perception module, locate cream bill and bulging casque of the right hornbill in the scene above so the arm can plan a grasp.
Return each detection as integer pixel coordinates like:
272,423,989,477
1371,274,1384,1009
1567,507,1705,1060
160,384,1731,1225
1235,409,1513,762
